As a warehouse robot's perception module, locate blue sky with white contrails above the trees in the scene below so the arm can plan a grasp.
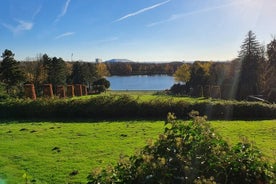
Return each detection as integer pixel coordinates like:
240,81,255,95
0,0,276,61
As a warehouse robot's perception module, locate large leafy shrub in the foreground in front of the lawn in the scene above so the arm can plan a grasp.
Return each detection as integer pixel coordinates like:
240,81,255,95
88,112,275,184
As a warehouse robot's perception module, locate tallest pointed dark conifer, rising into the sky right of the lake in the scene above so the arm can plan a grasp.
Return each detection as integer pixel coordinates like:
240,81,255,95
237,31,261,99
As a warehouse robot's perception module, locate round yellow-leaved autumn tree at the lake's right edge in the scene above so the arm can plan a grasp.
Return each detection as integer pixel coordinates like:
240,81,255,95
173,64,191,83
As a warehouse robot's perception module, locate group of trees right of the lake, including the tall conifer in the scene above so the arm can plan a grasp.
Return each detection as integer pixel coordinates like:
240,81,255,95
172,31,276,102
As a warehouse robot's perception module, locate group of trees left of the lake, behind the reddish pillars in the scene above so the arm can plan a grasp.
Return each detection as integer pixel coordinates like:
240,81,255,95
0,49,109,97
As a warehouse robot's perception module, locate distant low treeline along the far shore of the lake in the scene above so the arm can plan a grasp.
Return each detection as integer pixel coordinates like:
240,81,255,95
106,62,183,76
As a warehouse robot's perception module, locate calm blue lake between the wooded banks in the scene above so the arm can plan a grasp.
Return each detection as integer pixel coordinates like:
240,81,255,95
107,75,174,90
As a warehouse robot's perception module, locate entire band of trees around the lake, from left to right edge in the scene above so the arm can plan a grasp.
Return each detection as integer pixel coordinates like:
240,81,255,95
0,31,276,101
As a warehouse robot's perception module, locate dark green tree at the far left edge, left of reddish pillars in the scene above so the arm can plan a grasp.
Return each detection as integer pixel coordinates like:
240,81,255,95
0,49,24,94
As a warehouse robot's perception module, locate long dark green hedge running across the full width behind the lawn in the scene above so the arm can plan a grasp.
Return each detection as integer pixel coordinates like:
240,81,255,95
0,94,276,120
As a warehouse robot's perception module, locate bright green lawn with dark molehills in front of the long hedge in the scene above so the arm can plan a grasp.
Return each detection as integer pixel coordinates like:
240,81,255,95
0,120,276,184
